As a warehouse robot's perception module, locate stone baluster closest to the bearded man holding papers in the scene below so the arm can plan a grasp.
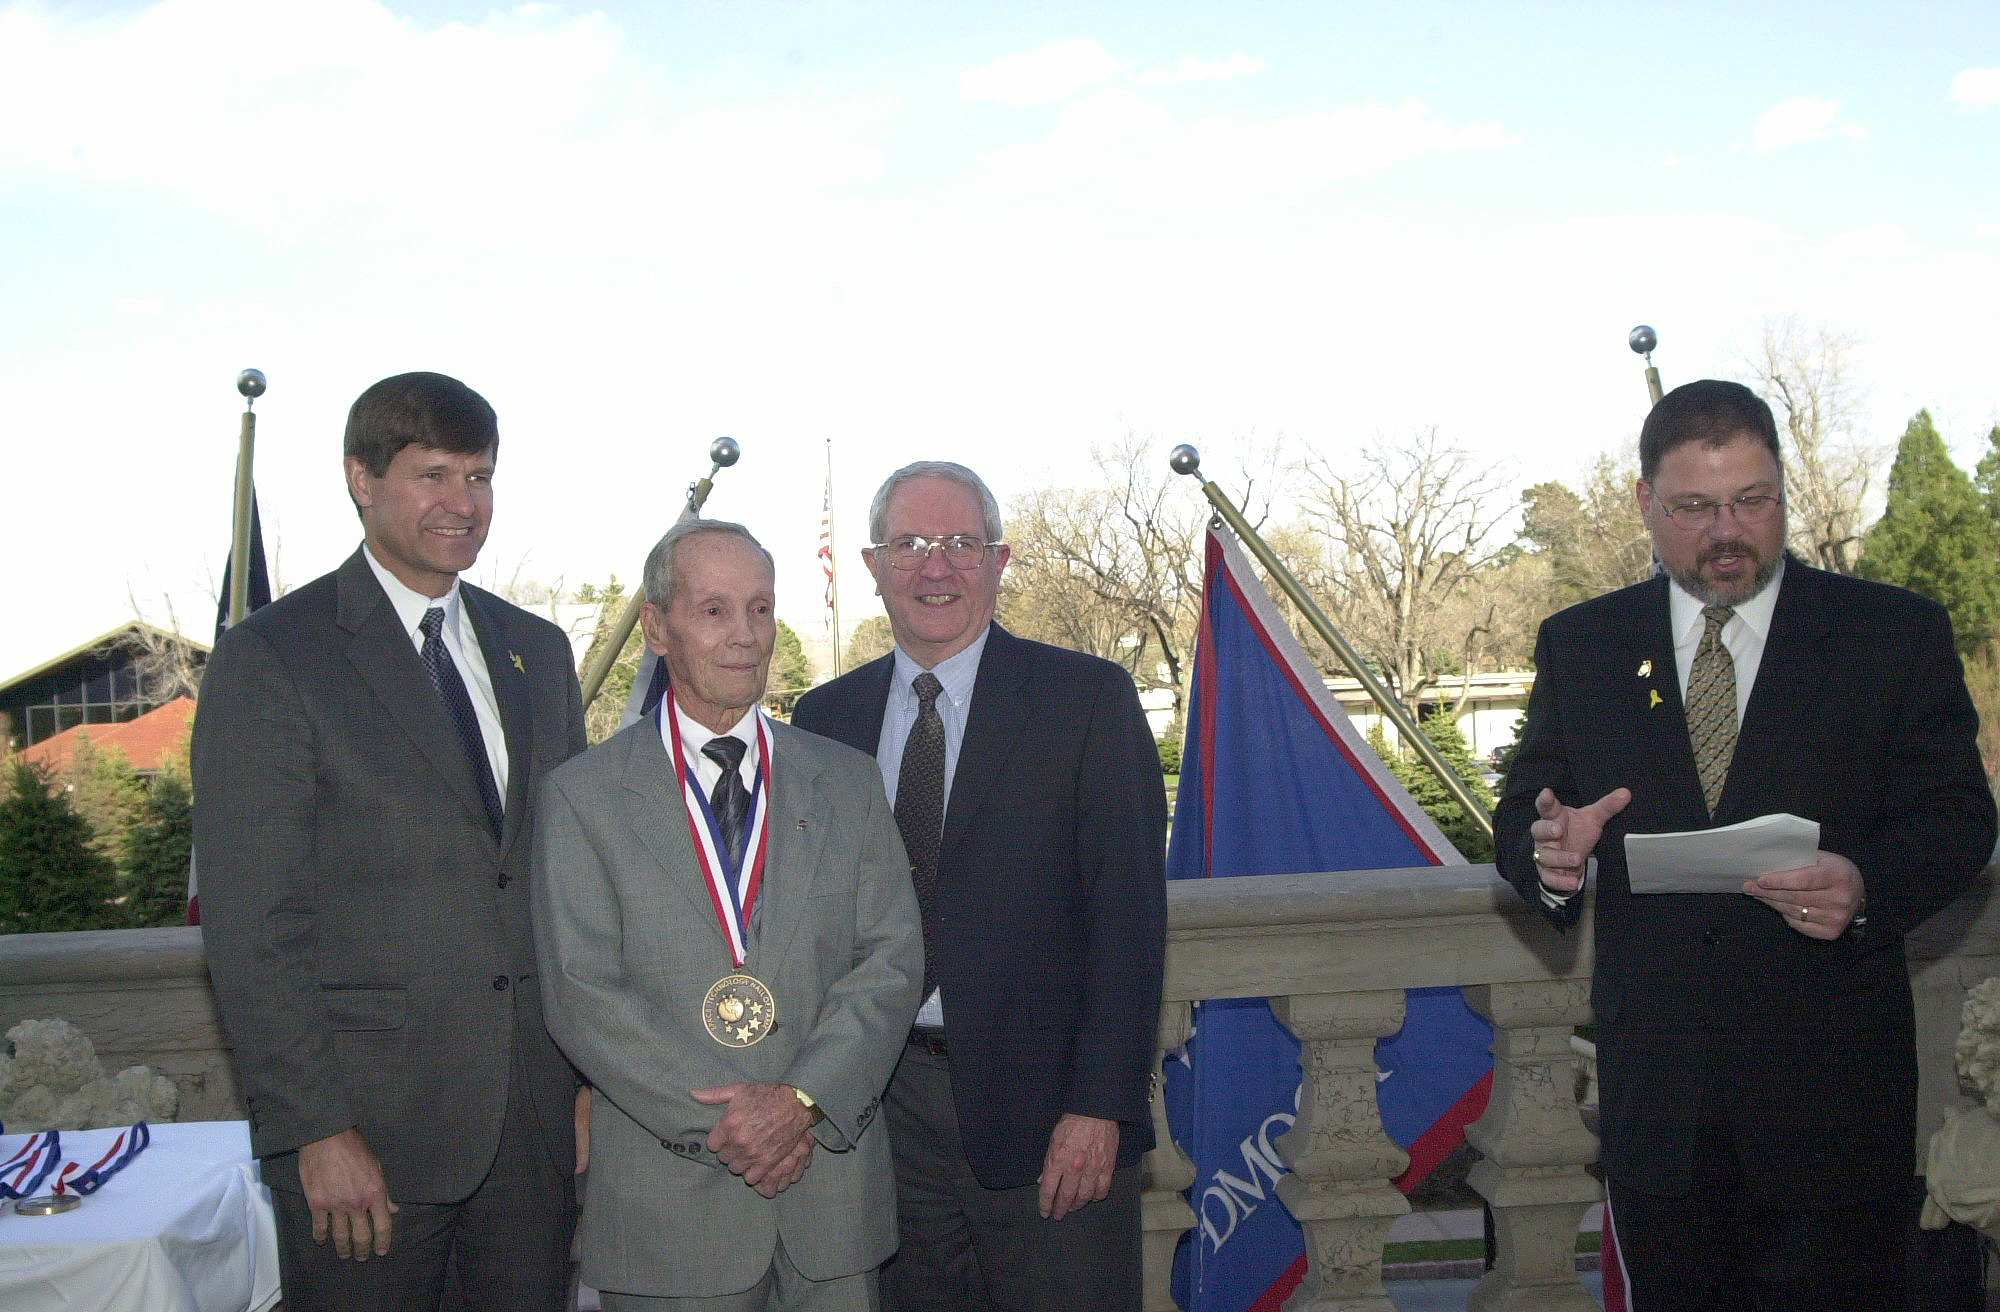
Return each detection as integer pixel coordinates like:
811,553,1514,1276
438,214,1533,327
1464,978,1602,1312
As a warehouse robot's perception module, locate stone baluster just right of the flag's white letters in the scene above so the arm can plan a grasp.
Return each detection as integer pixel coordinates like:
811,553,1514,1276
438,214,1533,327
1272,988,1410,1312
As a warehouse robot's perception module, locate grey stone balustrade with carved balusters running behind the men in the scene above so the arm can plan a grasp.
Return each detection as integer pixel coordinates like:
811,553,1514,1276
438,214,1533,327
0,866,2000,1312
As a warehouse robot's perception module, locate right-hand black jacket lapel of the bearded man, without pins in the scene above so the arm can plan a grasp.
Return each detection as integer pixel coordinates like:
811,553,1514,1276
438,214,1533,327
1716,560,1830,822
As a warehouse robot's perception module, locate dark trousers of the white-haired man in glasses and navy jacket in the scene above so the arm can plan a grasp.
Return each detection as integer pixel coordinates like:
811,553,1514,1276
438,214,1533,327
882,1048,1140,1312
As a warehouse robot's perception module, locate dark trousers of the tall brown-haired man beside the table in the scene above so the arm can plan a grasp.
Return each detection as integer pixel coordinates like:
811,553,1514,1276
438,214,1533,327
272,1056,576,1312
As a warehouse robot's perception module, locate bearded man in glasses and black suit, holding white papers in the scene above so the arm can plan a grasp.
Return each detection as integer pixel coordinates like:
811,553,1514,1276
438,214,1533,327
1494,380,1994,1312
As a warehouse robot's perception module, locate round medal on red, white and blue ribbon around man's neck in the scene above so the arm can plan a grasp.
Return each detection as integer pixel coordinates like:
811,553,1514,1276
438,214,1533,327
660,696,778,1048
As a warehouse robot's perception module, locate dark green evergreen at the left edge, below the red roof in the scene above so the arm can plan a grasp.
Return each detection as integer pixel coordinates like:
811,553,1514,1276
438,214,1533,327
0,760,116,934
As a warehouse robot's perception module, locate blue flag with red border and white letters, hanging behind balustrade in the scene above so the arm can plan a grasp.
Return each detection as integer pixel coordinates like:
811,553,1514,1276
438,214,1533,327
1166,530,1492,1312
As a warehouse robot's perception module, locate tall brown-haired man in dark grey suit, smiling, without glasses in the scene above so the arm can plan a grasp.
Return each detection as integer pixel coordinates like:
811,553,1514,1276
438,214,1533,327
194,374,584,1312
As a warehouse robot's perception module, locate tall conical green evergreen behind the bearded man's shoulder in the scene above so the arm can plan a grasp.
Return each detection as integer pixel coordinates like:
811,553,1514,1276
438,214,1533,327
1858,410,2000,654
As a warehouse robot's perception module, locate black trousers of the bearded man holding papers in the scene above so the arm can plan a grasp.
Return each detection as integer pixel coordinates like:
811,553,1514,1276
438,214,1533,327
1604,1122,1910,1312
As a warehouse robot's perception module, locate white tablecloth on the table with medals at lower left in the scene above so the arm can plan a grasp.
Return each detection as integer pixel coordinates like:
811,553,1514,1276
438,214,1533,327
0,1120,278,1312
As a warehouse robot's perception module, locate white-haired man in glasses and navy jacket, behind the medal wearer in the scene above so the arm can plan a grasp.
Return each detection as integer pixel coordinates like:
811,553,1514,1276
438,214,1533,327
794,462,1166,1312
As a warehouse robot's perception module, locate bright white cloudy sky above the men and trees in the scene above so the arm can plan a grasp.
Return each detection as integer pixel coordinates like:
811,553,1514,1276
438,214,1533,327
0,0,2000,676
